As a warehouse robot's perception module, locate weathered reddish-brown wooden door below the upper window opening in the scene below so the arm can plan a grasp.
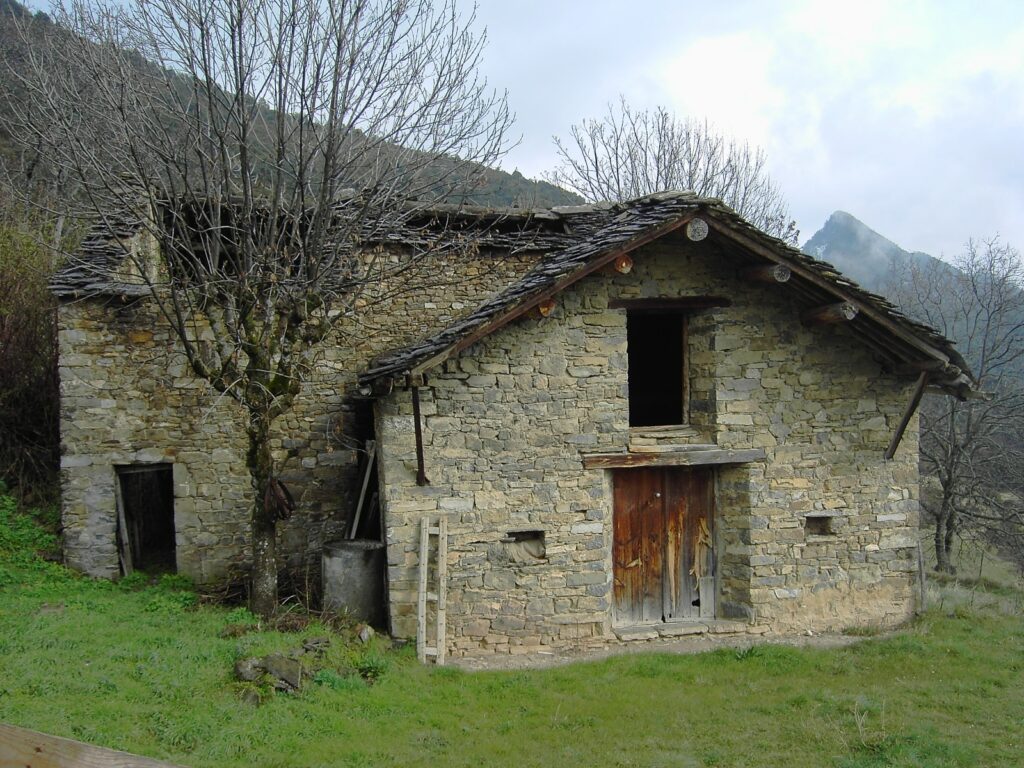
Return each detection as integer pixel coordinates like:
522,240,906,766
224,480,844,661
612,468,714,625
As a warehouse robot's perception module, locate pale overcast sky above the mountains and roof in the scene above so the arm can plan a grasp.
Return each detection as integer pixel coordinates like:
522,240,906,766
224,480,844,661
478,0,1024,256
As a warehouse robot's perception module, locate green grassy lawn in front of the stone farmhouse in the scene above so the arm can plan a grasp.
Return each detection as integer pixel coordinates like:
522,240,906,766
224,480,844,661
0,497,1024,768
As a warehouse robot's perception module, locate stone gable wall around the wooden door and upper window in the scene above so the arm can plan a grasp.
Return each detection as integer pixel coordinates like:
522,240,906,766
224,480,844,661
376,239,918,653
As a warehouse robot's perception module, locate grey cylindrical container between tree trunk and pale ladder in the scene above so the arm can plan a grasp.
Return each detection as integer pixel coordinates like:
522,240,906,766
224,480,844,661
323,539,387,629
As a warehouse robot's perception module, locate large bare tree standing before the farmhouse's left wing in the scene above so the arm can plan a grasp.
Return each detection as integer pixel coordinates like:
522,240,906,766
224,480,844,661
4,0,511,614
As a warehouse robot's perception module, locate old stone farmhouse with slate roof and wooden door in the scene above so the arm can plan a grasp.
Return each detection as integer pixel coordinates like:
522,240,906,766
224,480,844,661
53,193,973,658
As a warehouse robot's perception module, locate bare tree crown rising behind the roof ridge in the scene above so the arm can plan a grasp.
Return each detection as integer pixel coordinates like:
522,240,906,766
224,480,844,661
547,97,800,245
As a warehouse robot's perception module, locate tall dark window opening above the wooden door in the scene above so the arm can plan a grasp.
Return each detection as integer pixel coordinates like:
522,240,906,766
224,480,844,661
626,312,687,427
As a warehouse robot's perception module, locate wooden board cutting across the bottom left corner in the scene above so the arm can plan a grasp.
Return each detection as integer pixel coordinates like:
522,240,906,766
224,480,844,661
0,723,180,768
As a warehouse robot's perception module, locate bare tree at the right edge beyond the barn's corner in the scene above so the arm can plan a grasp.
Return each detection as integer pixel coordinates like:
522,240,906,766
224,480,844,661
889,239,1024,572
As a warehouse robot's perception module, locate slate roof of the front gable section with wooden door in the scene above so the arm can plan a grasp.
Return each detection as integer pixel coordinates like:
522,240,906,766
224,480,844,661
359,193,973,396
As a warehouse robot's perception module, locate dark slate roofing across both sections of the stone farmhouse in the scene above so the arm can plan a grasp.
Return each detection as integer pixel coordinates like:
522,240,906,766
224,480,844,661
50,191,974,396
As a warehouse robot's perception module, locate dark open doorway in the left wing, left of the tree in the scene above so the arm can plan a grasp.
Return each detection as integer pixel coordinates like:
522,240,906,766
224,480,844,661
117,464,177,574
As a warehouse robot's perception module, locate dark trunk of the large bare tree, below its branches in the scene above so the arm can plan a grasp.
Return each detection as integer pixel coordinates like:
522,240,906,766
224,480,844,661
247,414,278,618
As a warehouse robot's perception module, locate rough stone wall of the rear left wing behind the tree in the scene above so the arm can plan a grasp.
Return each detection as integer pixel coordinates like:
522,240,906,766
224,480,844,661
59,243,536,583
